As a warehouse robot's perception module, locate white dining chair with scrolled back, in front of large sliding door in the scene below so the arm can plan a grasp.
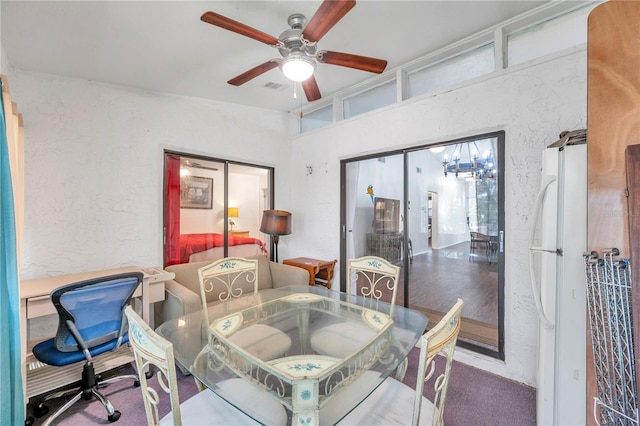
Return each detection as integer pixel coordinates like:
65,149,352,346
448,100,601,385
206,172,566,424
310,256,400,358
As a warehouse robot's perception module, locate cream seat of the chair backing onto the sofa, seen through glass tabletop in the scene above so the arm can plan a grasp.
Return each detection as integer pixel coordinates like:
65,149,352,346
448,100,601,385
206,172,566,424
229,324,291,361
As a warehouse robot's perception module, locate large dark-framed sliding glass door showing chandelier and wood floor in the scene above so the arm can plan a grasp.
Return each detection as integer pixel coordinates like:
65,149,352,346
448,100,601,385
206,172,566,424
341,132,504,359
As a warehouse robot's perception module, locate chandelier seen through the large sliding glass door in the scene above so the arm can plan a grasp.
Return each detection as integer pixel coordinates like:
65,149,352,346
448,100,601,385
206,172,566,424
442,142,497,180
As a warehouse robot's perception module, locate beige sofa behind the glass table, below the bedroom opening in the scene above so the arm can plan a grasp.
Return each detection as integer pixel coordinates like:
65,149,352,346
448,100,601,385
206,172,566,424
155,254,309,326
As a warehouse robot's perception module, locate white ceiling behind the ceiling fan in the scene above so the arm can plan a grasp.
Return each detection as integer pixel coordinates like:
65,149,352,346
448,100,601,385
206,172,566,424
0,0,546,111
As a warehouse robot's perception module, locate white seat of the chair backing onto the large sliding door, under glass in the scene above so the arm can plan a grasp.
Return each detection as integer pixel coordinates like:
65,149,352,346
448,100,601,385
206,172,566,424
311,321,376,358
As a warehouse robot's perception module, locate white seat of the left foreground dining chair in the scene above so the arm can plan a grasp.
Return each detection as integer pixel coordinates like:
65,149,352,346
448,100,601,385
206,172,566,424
160,379,287,426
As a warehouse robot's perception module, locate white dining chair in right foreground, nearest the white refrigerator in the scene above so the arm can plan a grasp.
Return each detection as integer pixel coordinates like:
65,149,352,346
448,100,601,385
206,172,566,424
330,299,464,426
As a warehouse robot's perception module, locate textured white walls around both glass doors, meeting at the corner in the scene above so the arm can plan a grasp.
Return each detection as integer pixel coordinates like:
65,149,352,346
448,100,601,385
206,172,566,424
11,50,587,385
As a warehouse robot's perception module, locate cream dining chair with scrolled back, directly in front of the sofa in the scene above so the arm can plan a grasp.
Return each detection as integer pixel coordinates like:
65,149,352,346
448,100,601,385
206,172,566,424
198,257,291,361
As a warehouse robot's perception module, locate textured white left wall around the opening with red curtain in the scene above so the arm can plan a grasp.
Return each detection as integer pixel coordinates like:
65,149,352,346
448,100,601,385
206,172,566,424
11,70,290,279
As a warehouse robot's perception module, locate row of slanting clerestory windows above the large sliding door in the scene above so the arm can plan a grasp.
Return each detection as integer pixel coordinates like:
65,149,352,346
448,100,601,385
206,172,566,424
300,1,601,133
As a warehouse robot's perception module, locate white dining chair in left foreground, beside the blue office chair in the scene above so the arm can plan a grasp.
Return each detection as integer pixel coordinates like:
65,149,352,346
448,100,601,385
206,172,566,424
125,306,287,426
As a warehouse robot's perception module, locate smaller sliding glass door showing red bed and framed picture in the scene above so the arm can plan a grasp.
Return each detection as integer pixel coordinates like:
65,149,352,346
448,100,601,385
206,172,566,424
164,151,273,266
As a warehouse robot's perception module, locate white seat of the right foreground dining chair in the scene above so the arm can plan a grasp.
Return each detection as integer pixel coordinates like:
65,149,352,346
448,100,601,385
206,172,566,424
338,377,435,426
